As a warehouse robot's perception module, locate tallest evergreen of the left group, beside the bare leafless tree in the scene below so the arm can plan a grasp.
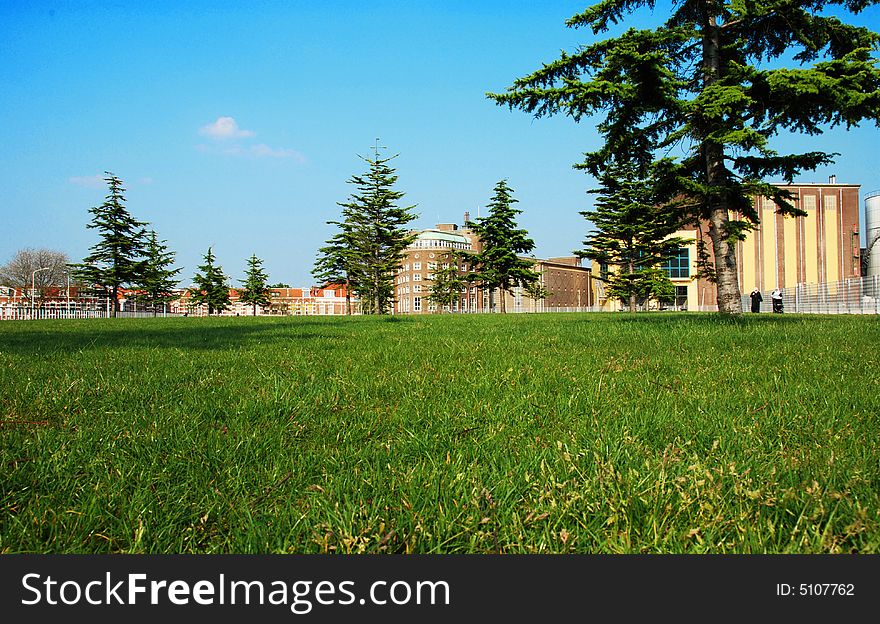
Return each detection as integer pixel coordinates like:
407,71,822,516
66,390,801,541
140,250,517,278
72,171,147,316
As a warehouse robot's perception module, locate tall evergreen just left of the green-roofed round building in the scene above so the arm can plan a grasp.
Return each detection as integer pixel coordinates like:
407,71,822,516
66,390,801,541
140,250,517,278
328,148,416,314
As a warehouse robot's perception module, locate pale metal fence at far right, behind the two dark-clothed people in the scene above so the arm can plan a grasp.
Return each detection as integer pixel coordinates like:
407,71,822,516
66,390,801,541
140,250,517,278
742,275,880,314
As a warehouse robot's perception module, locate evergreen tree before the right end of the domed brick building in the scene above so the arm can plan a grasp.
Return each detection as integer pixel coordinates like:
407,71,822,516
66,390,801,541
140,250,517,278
465,180,538,312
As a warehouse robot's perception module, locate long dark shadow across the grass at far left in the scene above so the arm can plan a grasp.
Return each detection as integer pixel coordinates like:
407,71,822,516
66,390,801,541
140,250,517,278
0,317,348,354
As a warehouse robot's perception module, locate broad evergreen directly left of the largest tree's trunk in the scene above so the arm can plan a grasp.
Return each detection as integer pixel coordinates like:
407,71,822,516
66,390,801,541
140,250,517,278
575,161,687,312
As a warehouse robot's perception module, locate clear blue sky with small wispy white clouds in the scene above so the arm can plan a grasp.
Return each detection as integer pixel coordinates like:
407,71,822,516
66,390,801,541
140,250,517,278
0,0,880,286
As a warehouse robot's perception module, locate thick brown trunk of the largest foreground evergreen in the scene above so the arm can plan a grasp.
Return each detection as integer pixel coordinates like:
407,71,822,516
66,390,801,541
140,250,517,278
700,2,742,316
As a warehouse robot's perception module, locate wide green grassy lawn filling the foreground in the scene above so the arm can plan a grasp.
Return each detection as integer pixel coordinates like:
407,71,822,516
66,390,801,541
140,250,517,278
0,313,880,553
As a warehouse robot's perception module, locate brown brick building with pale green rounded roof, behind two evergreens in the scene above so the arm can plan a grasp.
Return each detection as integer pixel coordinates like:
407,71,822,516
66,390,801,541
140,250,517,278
394,218,593,314
